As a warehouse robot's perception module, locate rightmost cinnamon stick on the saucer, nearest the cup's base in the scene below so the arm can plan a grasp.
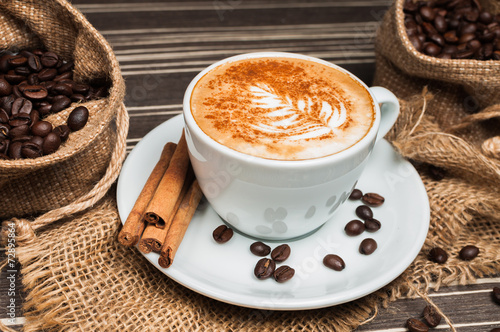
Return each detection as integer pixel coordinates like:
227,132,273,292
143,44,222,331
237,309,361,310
158,180,203,268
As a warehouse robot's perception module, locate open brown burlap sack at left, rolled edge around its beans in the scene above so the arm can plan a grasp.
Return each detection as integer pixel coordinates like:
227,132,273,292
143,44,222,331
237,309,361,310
0,0,128,223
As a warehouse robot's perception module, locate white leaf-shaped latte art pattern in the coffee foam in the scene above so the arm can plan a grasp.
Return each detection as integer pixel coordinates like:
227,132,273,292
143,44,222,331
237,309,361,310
250,84,347,140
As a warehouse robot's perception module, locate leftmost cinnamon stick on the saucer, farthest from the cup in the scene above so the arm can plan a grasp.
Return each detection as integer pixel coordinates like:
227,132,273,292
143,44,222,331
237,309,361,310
118,142,177,246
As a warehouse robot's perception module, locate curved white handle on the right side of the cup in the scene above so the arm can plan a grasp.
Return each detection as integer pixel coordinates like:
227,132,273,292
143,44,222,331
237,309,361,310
370,86,399,141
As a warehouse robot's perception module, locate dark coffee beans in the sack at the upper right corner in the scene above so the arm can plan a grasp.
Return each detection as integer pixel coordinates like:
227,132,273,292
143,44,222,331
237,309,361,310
403,0,500,60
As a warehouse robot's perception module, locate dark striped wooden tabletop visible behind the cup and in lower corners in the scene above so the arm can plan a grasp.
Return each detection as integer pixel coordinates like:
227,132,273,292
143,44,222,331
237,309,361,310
0,0,500,332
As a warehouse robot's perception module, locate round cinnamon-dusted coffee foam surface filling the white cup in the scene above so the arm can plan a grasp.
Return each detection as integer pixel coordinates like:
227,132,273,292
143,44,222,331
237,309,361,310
190,57,375,160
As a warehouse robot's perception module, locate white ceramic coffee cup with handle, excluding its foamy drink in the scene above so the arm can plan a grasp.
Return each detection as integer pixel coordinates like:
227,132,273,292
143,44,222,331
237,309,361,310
183,52,399,240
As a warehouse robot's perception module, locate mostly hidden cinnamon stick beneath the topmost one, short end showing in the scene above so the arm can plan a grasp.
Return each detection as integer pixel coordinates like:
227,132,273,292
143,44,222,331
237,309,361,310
139,167,194,254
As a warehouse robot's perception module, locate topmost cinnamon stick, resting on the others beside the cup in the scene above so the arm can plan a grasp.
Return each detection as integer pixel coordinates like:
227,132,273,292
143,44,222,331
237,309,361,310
144,132,189,229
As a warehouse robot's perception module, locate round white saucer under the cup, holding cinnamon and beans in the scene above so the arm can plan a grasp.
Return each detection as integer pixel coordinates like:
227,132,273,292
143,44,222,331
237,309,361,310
117,116,430,310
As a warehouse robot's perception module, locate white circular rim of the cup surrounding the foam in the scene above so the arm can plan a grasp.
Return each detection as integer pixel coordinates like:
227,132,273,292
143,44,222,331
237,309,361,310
182,52,381,168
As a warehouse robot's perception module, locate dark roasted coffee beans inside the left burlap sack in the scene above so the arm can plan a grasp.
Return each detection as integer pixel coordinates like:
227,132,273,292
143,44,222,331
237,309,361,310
0,50,107,159
